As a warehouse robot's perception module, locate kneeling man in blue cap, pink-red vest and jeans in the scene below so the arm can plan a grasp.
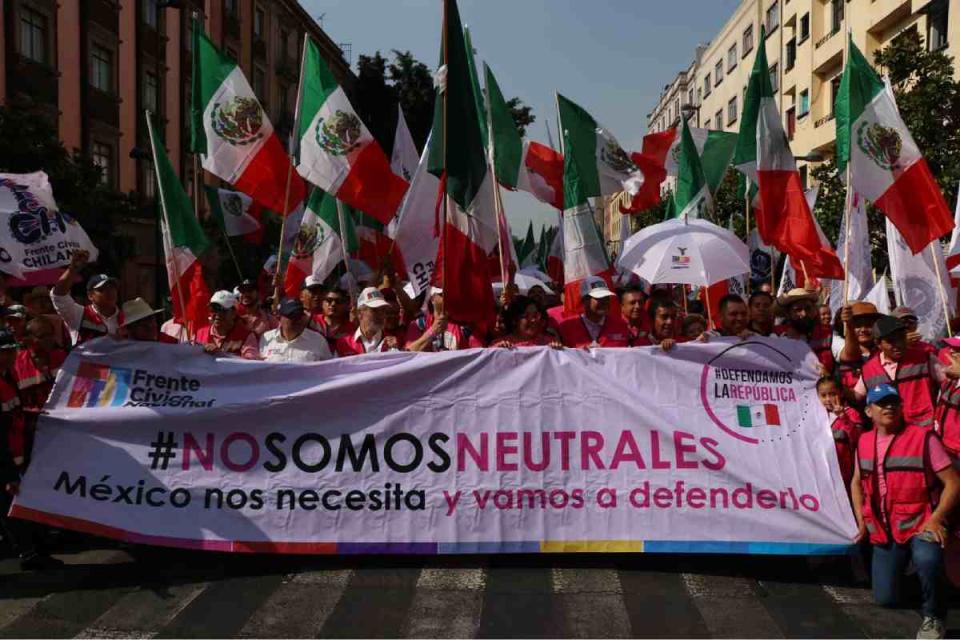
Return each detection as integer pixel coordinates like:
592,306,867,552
850,384,960,638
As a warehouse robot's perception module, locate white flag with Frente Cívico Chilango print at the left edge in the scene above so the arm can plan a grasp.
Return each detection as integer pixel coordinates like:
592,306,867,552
0,171,99,278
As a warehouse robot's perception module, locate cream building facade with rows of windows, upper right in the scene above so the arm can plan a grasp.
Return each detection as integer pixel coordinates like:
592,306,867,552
647,0,960,189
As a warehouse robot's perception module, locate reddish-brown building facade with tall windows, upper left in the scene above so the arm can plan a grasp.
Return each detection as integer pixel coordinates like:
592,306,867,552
0,0,354,300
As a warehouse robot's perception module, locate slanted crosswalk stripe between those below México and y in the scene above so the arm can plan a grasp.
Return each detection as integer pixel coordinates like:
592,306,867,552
237,569,353,638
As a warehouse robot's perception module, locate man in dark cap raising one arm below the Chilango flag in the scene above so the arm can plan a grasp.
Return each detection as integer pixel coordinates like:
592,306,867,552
50,249,123,345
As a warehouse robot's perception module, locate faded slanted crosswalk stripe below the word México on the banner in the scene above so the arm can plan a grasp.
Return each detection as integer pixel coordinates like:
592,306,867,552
77,582,210,638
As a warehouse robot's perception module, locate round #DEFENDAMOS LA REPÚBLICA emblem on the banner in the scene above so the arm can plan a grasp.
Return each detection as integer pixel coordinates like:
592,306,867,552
700,341,802,444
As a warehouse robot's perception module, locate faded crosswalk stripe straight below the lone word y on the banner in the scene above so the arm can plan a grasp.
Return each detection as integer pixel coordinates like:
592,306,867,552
404,567,486,638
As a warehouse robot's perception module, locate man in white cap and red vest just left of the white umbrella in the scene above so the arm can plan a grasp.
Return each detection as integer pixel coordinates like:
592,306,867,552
559,276,630,349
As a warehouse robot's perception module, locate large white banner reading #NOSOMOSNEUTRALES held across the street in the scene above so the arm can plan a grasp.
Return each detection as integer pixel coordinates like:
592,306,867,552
12,339,856,554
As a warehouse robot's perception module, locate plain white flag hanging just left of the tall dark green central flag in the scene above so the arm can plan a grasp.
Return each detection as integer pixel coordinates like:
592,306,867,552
387,138,440,295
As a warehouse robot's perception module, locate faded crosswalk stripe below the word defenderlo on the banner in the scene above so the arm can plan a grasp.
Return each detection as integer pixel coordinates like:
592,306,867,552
682,573,783,638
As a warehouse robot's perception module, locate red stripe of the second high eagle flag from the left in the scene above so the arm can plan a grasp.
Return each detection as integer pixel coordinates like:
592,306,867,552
337,142,410,224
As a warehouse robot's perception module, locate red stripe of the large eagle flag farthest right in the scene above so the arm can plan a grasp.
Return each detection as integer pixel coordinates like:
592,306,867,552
874,158,953,254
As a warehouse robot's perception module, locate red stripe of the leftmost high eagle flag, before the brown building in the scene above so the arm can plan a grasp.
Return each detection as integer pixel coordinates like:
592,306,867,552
233,134,307,215
